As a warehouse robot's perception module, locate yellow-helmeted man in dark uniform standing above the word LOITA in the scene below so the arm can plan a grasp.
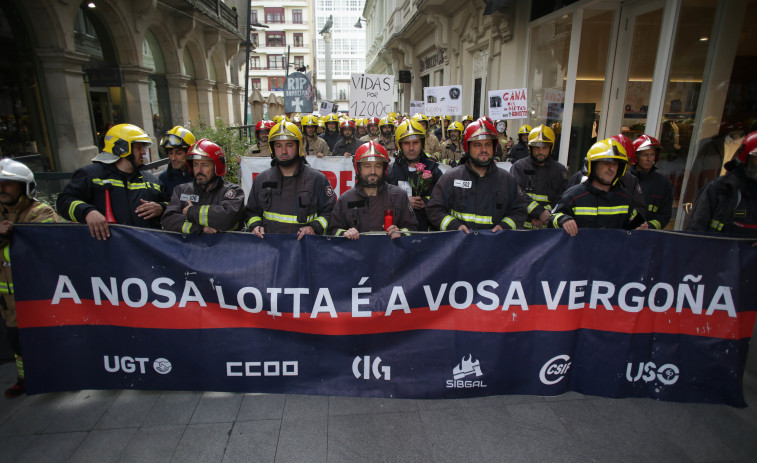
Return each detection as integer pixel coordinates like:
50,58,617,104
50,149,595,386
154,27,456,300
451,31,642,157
245,121,336,240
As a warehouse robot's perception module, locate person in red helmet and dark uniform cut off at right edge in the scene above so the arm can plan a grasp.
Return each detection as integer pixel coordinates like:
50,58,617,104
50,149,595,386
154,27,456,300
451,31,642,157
686,132,757,237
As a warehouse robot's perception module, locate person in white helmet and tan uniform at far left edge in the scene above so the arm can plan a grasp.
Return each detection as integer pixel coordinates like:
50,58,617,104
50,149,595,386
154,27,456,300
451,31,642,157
0,158,63,399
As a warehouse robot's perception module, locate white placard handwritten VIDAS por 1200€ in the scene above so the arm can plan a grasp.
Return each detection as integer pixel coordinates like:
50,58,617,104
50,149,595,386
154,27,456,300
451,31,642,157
350,73,394,118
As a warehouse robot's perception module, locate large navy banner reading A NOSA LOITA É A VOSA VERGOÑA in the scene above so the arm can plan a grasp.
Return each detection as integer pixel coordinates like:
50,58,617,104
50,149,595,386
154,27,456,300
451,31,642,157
10,224,757,406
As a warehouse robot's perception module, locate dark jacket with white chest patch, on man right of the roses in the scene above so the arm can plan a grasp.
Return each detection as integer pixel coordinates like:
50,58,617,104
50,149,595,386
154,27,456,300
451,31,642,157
426,161,526,230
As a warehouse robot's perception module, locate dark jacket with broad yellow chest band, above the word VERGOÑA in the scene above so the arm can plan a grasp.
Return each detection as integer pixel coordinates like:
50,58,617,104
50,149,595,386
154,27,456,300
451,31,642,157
549,179,645,230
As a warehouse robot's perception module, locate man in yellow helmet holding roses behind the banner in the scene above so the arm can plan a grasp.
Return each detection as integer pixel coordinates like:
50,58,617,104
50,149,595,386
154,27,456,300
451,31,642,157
386,118,442,231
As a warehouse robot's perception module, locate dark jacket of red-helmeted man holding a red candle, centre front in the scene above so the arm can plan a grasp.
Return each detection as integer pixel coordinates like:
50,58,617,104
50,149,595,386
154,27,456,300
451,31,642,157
329,182,418,236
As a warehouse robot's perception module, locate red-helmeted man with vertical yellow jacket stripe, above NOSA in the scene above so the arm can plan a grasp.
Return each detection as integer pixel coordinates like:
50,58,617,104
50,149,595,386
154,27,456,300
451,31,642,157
161,138,244,234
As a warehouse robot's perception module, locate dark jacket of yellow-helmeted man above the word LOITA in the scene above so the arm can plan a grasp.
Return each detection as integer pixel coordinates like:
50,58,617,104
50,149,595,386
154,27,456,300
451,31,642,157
244,161,336,235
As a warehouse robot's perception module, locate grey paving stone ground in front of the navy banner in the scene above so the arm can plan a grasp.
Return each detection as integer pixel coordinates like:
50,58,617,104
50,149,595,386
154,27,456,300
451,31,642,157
0,363,757,463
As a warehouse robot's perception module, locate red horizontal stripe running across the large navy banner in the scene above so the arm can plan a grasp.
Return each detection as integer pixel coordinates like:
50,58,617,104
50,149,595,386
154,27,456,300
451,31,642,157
16,300,757,339
